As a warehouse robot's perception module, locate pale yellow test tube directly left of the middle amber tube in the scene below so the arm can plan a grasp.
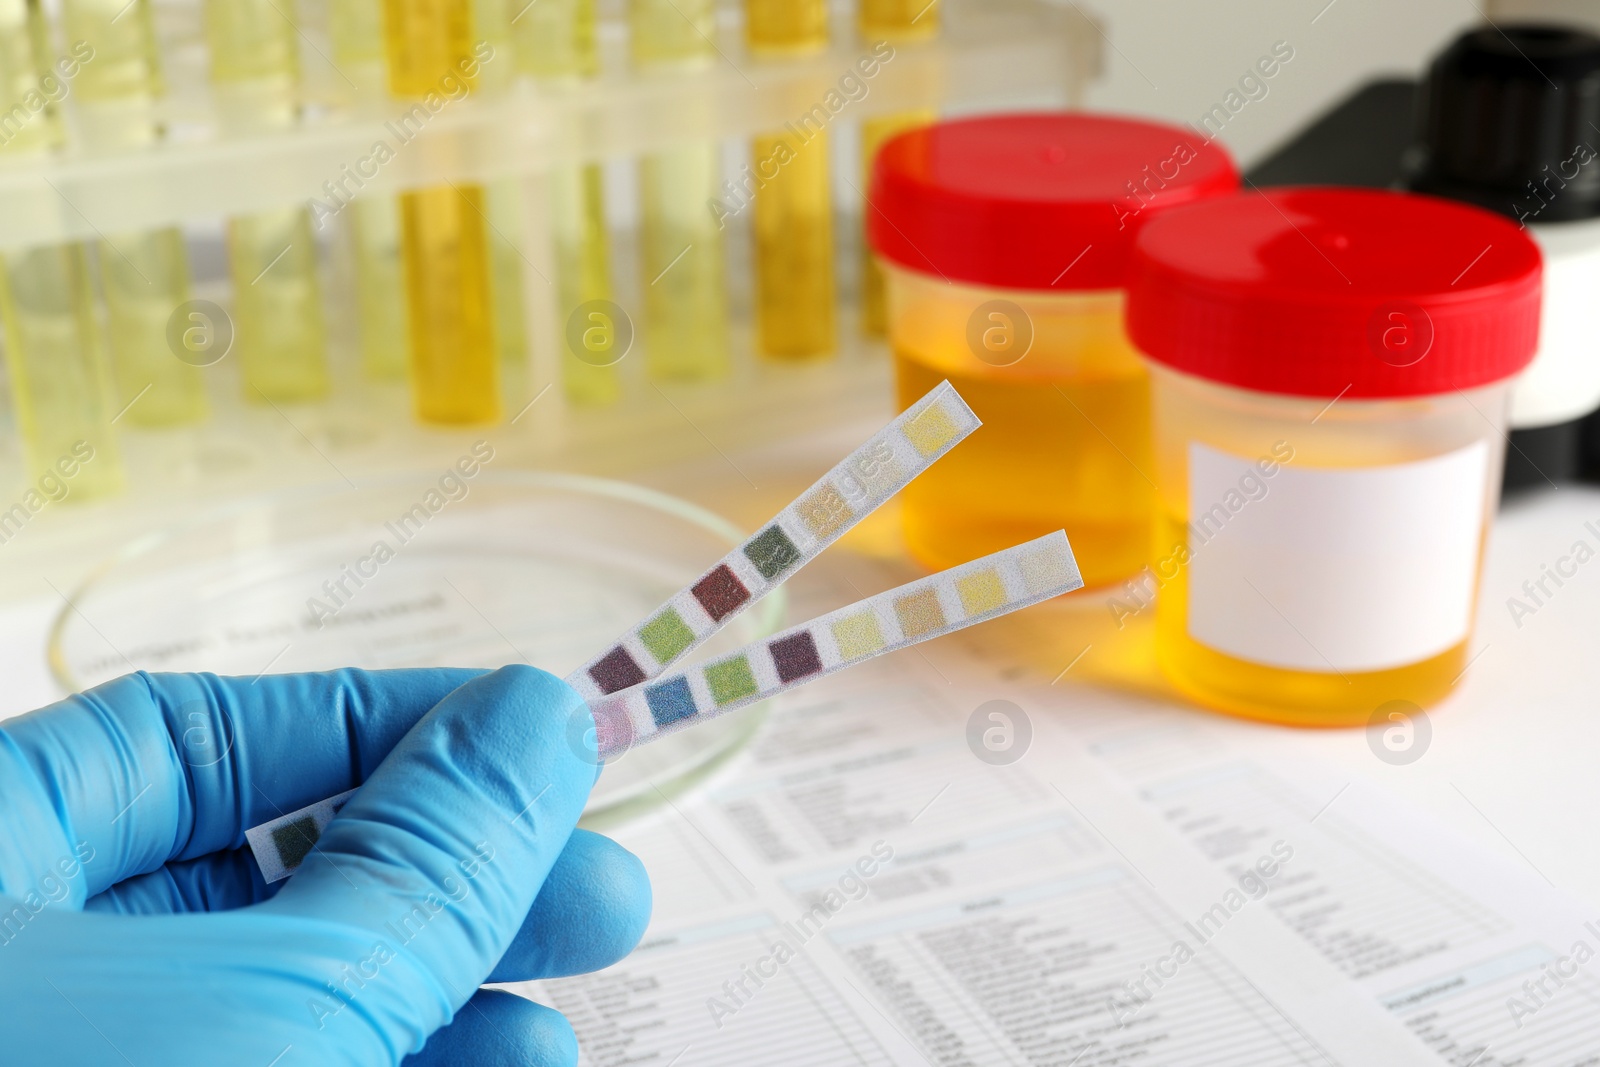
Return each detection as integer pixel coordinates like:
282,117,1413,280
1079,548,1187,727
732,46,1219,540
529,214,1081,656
627,0,731,381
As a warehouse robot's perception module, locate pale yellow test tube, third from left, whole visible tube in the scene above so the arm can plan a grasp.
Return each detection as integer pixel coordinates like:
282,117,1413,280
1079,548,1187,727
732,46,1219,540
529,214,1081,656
205,0,328,402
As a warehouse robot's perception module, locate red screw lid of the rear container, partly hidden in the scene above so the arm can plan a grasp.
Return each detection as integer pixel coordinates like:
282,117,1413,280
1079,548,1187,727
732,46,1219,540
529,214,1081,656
867,112,1238,290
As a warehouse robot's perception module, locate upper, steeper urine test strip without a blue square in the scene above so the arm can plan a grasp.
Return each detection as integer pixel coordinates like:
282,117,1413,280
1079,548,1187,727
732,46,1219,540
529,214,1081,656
566,382,981,701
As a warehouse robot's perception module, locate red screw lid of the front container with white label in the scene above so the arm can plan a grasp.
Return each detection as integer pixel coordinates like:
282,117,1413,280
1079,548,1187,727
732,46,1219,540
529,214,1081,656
1128,189,1542,397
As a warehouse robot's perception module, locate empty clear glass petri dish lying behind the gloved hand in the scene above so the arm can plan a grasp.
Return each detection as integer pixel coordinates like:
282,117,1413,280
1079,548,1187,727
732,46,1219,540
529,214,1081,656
48,469,786,825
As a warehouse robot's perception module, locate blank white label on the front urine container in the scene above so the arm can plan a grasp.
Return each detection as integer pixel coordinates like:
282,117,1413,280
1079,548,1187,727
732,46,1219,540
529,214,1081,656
1189,442,1488,673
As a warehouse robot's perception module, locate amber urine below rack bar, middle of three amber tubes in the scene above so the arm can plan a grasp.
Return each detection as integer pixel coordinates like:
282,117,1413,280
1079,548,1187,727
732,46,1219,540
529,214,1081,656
752,128,835,358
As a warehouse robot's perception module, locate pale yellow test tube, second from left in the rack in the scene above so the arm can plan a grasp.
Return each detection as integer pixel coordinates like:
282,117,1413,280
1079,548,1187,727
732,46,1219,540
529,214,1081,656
62,0,206,426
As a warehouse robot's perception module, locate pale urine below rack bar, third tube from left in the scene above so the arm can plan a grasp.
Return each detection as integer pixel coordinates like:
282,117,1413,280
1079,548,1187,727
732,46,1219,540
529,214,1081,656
227,208,328,402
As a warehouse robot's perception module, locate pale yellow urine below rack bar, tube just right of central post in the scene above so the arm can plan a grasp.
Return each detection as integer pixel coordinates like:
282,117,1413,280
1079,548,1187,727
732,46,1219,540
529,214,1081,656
550,163,622,405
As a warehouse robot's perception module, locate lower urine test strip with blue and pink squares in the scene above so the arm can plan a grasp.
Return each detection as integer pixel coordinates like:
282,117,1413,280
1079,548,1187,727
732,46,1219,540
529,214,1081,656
589,531,1083,760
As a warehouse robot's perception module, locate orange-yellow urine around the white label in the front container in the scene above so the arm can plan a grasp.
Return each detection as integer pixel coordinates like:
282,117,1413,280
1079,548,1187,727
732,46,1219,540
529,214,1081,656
1152,501,1486,726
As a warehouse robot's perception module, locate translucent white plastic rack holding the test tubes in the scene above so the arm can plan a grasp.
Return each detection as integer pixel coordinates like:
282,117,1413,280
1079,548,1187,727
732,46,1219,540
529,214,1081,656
0,0,1101,598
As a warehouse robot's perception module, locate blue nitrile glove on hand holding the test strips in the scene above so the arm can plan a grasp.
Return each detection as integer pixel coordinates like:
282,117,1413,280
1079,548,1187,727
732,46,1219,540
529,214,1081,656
0,667,650,1067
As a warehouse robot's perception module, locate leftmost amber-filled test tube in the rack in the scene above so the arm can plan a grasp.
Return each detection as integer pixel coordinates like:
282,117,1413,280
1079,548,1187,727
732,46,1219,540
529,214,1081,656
384,0,501,424
